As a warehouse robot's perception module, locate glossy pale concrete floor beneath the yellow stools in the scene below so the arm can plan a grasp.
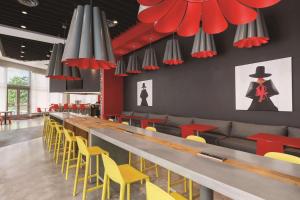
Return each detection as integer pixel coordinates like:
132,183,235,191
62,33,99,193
0,119,227,200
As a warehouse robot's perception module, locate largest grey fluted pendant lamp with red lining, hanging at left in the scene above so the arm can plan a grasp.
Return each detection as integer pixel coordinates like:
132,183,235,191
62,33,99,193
62,5,116,69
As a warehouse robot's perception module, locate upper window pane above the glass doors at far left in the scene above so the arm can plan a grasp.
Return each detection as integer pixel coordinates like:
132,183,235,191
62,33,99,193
7,68,30,86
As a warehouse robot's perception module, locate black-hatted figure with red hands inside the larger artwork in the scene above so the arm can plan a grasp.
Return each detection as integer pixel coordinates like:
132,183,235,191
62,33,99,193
246,66,279,111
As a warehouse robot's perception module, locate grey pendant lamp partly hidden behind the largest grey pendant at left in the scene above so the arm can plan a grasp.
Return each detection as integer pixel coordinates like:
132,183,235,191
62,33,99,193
47,43,81,80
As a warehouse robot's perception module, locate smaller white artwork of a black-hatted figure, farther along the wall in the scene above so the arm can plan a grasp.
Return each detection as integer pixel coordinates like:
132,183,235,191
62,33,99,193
137,80,153,106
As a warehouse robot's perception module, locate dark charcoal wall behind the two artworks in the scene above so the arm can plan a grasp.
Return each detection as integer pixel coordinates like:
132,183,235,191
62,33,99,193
124,1,300,127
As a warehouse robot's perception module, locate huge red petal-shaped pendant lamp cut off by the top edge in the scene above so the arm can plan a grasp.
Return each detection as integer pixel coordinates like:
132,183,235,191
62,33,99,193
138,0,280,37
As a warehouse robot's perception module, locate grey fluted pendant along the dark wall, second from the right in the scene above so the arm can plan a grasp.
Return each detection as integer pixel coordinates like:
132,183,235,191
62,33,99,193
191,28,217,58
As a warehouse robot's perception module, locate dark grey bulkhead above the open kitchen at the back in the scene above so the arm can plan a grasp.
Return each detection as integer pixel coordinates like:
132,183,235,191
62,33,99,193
50,69,100,92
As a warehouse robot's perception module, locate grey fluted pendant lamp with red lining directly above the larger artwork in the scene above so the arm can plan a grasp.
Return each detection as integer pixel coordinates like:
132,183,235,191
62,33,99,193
233,10,270,48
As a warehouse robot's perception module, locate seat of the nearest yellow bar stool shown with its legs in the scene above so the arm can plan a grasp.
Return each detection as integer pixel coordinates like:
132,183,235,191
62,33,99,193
119,164,148,183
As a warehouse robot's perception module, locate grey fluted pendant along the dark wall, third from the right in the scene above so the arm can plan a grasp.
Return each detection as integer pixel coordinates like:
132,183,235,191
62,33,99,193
163,35,183,65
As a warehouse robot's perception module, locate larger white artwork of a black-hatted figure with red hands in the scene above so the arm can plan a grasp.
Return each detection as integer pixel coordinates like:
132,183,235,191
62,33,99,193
235,57,293,112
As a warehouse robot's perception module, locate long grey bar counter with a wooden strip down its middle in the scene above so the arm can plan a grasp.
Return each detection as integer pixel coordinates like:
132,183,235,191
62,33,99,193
50,113,300,200
